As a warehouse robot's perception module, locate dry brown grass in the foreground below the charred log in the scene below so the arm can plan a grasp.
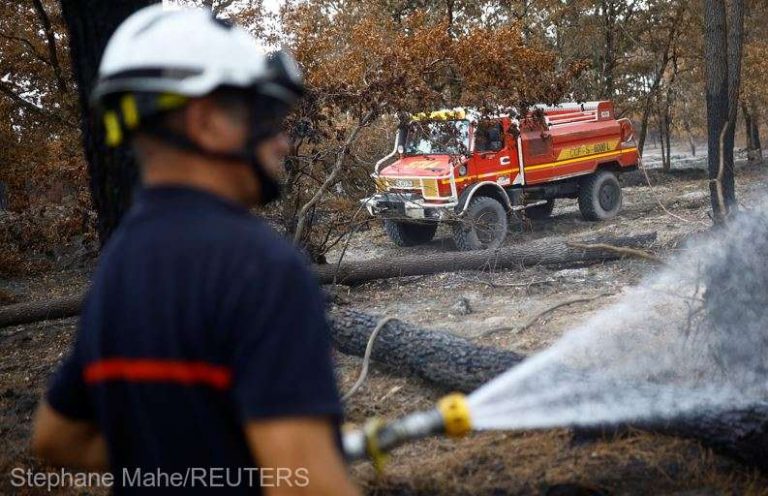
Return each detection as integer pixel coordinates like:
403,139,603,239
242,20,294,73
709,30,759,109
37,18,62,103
355,424,768,495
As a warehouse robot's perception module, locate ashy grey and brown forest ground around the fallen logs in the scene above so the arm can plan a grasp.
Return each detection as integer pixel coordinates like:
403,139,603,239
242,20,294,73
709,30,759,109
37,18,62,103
0,149,768,495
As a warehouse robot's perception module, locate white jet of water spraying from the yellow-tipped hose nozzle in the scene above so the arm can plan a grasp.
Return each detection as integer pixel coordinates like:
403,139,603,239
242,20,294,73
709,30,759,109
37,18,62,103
469,205,768,430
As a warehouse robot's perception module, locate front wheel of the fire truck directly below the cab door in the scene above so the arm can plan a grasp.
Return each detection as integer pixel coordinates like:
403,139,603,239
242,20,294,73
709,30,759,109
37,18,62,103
453,196,507,251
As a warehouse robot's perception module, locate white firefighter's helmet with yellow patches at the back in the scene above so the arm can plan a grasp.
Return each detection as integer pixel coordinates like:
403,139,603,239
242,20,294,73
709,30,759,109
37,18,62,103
91,4,303,146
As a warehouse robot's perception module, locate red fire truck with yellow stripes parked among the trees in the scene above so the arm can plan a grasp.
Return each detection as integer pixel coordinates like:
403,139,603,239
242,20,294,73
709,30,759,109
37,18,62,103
363,101,640,250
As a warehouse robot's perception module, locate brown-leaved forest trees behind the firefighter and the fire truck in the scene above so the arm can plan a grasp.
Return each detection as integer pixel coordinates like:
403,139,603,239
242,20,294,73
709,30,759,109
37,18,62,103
0,0,768,276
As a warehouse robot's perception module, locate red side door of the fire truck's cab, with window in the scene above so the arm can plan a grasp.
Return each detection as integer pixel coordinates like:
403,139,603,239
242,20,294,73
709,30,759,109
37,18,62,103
472,121,516,186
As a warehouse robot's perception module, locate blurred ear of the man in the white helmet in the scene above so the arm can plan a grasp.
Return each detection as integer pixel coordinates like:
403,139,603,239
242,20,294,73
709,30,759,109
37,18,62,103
184,97,245,152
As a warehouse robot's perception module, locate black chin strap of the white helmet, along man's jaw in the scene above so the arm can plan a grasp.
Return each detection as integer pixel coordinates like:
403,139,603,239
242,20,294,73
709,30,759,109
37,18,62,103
142,122,282,206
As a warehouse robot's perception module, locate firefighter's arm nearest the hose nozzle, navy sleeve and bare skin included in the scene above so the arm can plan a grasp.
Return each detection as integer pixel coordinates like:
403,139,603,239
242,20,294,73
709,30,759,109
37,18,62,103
230,254,358,496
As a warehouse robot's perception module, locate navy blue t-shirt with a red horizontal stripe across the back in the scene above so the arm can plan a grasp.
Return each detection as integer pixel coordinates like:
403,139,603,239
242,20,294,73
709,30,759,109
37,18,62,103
47,187,342,494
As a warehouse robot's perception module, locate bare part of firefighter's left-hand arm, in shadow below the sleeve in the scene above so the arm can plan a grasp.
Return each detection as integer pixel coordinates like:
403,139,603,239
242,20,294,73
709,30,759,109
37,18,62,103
31,400,109,472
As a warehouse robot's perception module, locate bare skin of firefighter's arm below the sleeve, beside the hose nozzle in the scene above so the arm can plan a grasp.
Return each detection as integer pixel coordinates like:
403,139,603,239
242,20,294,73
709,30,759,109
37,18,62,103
245,417,359,496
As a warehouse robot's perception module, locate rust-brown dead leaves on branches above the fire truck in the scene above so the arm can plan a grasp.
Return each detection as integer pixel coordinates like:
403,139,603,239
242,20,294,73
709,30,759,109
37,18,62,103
283,0,584,120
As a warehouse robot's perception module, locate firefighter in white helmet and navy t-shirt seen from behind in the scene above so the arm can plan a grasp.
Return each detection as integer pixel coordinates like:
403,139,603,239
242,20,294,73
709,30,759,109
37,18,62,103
27,5,356,495
